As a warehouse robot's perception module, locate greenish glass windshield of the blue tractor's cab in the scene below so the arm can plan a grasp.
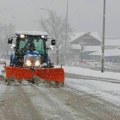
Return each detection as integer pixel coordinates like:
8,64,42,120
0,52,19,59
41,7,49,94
19,36,45,55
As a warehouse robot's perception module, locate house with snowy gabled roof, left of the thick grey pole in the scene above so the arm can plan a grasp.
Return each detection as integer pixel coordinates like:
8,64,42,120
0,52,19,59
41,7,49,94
70,32,101,60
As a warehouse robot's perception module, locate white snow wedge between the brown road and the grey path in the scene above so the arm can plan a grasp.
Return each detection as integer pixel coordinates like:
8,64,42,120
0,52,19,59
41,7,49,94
66,79,120,106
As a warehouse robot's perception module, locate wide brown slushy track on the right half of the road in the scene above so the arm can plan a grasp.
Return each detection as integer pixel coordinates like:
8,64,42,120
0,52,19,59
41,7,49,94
28,84,119,120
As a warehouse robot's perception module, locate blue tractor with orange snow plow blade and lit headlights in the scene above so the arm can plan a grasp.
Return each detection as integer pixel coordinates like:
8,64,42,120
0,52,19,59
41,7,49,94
5,32,64,86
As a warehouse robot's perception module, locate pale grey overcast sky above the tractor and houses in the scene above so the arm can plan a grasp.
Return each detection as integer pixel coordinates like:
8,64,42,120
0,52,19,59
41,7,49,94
0,0,120,38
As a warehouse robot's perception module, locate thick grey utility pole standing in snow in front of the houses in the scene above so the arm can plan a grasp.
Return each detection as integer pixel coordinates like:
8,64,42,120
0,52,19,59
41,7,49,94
101,0,106,72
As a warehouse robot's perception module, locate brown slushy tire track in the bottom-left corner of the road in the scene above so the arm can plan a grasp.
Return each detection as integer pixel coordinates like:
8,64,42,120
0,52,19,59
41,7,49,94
0,86,42,120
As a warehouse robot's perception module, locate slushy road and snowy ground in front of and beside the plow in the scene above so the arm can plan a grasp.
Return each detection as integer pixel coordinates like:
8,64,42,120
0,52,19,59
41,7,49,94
0,66,120,120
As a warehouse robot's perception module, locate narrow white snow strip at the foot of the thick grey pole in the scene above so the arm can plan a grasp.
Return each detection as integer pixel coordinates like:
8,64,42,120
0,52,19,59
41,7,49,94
63,66,120,80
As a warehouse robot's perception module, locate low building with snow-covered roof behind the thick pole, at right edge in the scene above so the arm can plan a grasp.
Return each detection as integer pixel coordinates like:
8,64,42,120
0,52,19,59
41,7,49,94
90,39,120,63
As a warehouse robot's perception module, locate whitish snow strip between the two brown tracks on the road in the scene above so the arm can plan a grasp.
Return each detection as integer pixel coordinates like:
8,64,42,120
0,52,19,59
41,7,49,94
23,85,79,120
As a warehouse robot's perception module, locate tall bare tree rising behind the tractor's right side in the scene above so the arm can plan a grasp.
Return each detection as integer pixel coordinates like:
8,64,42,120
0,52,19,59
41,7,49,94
40,10,72,64
